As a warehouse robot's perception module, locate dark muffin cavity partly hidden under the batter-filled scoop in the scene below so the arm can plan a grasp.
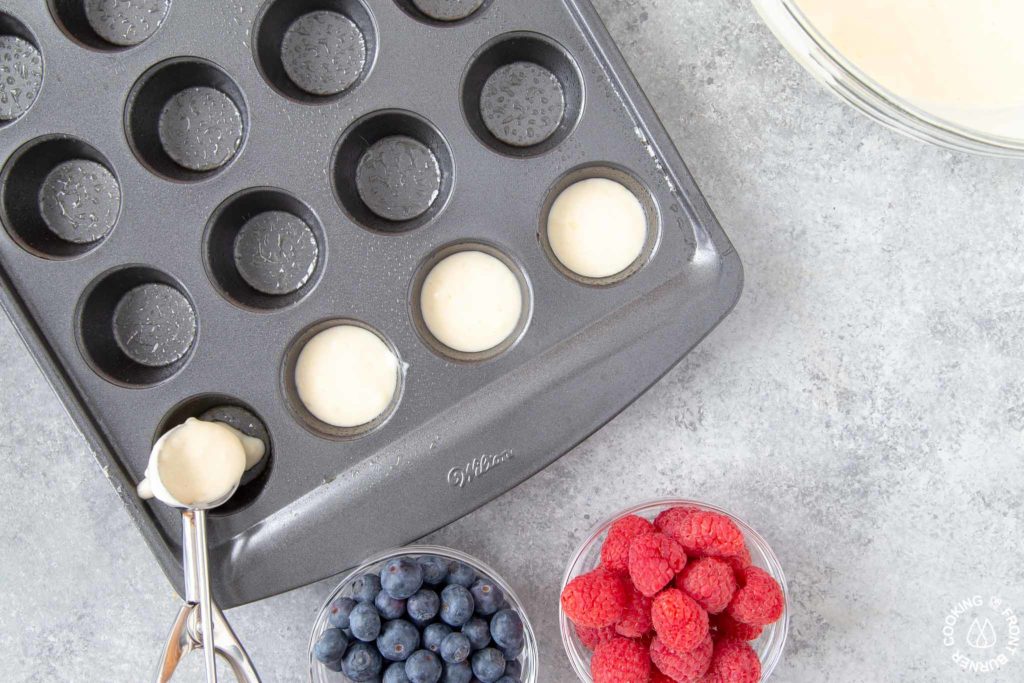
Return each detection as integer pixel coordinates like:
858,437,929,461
153,393,274,516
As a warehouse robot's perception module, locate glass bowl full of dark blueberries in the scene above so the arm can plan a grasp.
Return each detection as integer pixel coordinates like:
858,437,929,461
309,546,538,683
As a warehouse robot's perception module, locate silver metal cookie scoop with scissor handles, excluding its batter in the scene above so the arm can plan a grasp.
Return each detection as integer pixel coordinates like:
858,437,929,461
140,423,260,683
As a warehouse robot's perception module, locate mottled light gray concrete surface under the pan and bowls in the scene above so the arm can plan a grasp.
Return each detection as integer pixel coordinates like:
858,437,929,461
0,0,1024,683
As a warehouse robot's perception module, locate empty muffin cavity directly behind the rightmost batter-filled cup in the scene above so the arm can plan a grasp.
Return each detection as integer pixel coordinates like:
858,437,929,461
462,33,584,157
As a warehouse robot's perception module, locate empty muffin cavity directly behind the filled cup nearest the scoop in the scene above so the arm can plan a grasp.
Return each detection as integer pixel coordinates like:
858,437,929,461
204,187,326,310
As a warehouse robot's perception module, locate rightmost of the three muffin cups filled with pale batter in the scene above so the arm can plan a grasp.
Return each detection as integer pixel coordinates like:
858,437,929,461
539,166,660,287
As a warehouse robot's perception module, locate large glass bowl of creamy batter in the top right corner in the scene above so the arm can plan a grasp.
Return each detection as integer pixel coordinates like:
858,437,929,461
753,0,1024,158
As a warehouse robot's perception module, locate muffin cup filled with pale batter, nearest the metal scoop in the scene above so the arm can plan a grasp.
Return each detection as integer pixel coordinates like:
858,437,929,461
282,319,404,439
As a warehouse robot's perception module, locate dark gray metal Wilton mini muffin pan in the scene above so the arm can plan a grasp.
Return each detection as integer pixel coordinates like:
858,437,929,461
0,0,742,607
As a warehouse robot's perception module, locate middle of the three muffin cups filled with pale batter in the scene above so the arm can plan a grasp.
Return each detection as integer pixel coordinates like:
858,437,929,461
412,243,532,362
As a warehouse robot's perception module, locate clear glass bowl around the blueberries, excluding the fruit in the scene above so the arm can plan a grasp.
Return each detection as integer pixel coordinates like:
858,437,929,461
309,546,540,683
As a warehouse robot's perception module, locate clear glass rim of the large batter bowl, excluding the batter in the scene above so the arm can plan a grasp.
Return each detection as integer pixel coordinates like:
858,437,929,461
752,0,1024,158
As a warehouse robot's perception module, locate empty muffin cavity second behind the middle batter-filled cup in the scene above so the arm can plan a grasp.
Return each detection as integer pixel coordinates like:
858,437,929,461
253,0,377,103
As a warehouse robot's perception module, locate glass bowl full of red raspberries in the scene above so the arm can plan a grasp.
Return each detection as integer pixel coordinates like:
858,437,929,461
559,500,788,683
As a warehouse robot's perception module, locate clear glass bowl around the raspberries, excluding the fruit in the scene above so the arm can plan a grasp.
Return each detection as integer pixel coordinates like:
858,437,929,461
558,499,790,683
